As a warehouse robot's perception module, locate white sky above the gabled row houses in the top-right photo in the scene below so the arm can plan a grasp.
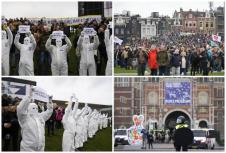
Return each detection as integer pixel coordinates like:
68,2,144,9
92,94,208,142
113,0,224,17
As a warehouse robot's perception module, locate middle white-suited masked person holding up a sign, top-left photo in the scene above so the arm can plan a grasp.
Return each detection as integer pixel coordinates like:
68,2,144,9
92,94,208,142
45,35,72,75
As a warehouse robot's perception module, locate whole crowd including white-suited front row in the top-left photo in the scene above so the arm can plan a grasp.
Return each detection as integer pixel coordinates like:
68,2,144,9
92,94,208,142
2,18,112,75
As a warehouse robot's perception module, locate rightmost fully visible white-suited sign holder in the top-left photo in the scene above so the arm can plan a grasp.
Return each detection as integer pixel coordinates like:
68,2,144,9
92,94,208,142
77,34,99,76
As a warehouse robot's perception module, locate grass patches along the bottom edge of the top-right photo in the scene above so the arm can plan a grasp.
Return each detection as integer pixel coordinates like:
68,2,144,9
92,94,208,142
114,67,224,76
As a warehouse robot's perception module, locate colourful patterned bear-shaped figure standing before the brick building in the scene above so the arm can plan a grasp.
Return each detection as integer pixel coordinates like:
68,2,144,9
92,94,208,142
128,115,144,145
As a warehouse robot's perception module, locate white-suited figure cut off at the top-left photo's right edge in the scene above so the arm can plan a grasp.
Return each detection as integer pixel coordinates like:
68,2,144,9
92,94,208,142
104,29,112,75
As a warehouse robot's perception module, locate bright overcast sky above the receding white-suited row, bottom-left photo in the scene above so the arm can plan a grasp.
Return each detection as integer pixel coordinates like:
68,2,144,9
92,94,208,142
17,77,113,105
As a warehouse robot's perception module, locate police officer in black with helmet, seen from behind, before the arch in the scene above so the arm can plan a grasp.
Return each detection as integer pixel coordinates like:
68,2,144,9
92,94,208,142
174,116,194,151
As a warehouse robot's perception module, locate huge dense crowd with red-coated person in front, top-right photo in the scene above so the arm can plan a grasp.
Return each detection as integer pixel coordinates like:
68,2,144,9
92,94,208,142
114,32,224,76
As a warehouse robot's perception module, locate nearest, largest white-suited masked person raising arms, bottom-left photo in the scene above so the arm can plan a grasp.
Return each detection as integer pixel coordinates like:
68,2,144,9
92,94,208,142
17,89,53,151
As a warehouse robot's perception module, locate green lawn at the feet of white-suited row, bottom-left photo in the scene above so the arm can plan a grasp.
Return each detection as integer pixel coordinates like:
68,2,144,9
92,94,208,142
45,127,112,151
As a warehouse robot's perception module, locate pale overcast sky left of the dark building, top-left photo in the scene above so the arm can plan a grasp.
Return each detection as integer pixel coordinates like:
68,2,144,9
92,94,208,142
2,1,78,18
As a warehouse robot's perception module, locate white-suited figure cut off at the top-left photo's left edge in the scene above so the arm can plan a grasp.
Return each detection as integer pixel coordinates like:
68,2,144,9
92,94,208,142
2,27,13,76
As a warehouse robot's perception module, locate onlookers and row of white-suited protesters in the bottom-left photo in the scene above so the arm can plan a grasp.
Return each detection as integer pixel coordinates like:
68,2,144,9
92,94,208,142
2,91,111,151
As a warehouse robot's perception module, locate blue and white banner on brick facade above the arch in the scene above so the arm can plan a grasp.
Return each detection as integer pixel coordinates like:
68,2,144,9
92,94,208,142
165,81,192,105
